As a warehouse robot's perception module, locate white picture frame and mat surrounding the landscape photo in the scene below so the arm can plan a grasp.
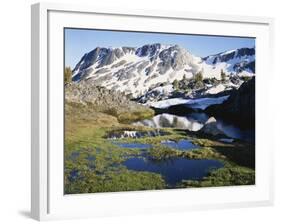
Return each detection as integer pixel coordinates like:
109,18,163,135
31,3,274,220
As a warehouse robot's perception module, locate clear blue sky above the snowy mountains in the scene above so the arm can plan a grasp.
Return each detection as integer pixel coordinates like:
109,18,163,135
65,28,255,68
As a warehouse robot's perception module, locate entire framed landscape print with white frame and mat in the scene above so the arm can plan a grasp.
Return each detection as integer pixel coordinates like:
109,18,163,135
31,3,273,220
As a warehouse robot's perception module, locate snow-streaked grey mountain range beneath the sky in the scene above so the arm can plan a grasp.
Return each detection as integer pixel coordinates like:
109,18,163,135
72,43,255,98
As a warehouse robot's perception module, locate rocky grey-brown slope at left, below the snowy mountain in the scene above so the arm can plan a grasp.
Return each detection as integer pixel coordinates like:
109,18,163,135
65,81,154,123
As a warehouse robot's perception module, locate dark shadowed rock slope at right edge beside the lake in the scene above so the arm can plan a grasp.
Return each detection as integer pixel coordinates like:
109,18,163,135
206,77,255,128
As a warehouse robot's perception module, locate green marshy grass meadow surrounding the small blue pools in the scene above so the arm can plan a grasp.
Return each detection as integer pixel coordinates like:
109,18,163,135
64,101,255,194
